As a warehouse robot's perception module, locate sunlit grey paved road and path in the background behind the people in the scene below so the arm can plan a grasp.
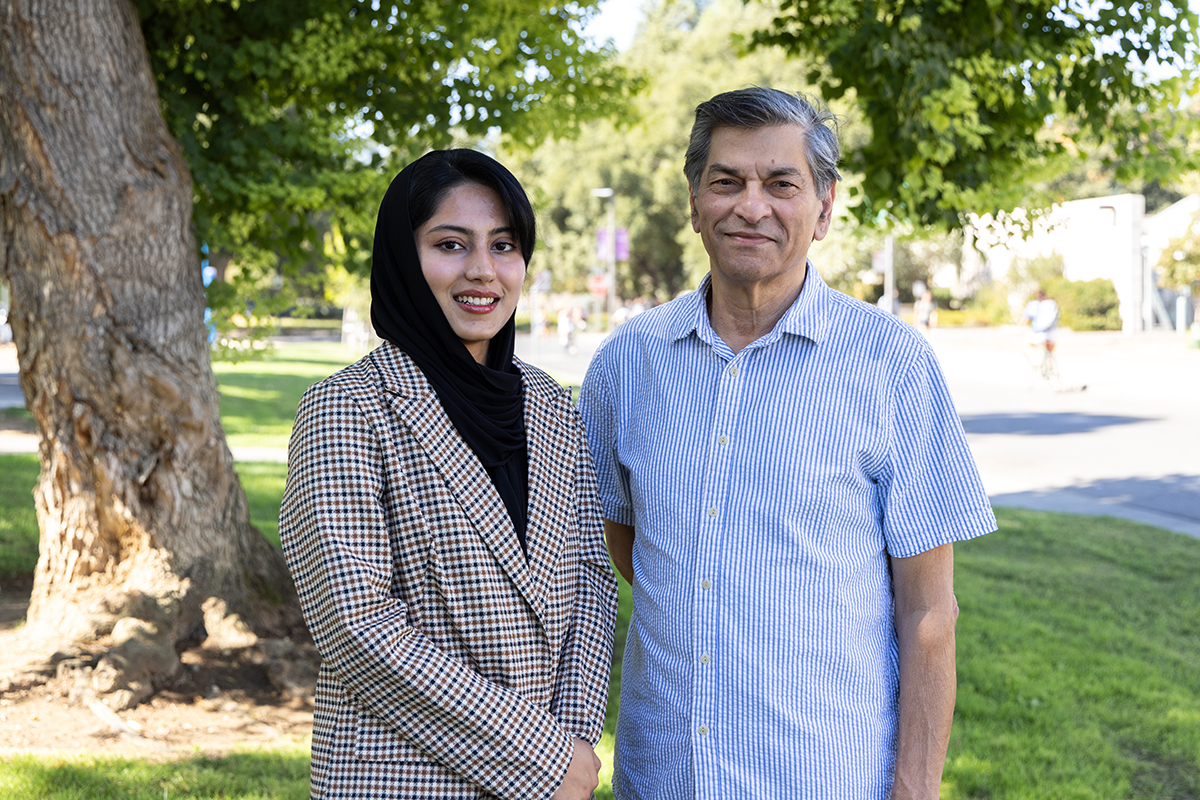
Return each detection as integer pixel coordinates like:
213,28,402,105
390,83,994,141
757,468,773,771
0,327,1200,536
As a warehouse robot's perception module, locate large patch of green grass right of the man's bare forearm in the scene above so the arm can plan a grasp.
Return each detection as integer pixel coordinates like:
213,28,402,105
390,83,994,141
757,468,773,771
942,509,1200,800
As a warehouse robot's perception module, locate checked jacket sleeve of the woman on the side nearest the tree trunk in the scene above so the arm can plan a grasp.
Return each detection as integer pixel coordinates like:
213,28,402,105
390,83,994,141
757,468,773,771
280,383,574,800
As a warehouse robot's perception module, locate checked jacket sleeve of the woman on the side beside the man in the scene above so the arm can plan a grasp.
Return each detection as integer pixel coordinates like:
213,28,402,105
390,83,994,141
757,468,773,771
551,411,618,746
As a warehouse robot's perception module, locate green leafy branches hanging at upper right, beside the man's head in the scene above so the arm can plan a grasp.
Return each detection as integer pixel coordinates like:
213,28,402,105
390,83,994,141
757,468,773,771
748,0,1200,227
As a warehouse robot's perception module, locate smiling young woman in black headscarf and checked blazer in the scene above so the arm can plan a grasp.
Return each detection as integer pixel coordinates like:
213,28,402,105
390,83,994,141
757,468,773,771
280,150,617,800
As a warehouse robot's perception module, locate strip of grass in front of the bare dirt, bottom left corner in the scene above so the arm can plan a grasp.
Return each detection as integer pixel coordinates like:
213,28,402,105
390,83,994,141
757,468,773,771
0,745,308,800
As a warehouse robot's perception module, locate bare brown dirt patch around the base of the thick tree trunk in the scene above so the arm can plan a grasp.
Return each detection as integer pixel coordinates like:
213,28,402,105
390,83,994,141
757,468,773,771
0,579,316,759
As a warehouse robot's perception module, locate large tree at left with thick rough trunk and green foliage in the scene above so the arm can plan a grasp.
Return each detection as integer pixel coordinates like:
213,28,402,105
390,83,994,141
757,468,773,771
0,0,628,706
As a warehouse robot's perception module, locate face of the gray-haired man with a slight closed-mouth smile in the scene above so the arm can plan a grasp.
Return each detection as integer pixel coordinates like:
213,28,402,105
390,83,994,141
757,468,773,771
691,125,834,283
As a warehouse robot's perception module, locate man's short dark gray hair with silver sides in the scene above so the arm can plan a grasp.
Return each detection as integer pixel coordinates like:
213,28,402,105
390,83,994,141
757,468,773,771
683,86,841,198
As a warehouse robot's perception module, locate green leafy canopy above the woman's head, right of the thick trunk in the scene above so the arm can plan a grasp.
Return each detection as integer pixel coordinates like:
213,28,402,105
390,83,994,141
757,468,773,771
137,0,623,316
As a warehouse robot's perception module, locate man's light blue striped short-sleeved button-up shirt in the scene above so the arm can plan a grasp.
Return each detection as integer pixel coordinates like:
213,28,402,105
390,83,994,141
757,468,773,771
581,264,996,800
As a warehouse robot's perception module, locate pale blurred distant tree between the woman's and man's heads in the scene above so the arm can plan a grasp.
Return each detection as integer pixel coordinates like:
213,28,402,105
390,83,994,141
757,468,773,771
510,0,862,300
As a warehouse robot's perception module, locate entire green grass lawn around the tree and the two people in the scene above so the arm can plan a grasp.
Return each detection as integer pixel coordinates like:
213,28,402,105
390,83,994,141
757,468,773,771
0,345,1200,800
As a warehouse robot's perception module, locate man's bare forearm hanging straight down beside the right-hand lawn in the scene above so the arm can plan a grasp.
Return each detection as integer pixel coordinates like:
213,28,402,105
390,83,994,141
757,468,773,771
892,608,958,800
